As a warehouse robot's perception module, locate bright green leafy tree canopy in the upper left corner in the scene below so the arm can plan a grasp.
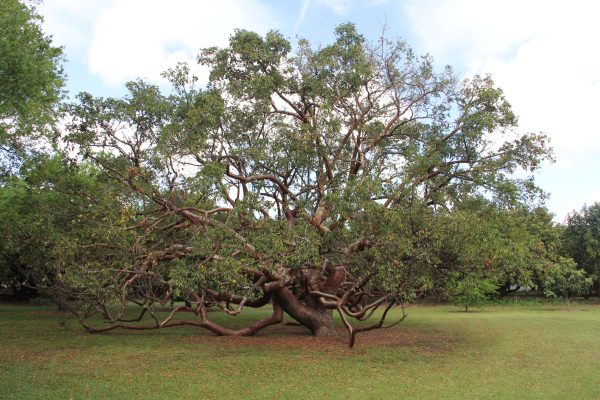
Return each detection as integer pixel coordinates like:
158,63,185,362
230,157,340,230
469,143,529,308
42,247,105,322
0,0,64,175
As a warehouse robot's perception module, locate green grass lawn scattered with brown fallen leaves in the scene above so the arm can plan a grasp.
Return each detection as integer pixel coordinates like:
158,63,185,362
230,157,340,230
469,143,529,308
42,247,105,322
0,304,600,399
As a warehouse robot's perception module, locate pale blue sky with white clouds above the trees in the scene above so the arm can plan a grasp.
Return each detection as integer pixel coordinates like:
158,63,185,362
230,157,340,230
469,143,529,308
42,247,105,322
38,0,600,222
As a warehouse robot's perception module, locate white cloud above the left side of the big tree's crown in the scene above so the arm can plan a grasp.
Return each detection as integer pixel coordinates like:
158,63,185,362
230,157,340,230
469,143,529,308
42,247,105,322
88,0,271,85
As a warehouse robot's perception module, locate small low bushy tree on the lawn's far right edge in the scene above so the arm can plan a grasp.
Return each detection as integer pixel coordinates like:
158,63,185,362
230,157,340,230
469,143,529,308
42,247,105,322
544,258,593,308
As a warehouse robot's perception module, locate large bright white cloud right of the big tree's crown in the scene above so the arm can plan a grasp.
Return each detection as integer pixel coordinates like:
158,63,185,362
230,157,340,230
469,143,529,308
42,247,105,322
405,0,600,164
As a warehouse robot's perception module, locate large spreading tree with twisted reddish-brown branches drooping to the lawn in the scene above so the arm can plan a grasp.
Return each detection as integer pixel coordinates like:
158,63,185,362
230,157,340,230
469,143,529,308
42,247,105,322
55,24,549,345
